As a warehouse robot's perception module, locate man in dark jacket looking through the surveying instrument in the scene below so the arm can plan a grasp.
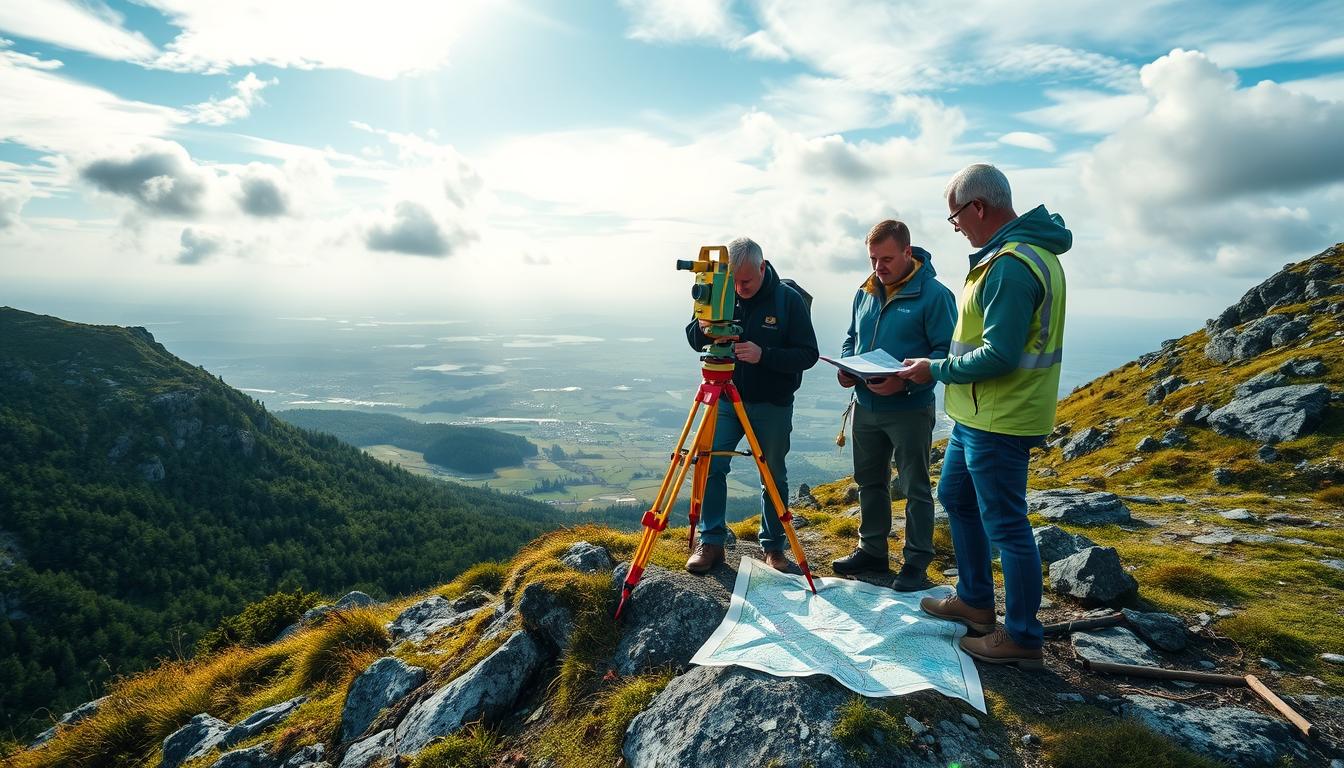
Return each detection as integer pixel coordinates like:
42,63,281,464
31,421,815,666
685,237,817,573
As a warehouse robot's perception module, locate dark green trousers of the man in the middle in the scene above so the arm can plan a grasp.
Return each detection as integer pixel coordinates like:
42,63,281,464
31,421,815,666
853,404,934,570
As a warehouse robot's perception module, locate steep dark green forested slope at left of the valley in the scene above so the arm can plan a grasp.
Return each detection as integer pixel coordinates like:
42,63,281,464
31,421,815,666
0,308,572,737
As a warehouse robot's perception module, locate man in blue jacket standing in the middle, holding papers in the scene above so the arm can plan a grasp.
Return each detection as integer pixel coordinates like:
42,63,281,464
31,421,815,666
831,219,957,592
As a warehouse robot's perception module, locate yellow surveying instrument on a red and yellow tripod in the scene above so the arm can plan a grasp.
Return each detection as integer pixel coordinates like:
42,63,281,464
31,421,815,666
616,245,817,619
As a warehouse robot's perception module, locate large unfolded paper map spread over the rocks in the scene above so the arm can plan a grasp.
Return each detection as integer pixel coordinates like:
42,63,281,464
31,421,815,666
691,557,985,712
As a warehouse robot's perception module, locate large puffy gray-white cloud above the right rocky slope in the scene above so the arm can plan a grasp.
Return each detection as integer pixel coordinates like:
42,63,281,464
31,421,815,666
1081,50,1344,280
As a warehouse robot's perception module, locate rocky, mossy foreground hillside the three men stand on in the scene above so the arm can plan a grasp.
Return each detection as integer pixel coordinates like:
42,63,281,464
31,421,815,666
9,247,1344,768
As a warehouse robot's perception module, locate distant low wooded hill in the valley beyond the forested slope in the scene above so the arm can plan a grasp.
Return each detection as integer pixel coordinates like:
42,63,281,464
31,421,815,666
278,409,536,473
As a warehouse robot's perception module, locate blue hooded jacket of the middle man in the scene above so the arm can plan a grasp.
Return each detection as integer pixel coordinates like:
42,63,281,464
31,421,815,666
840,247,957,410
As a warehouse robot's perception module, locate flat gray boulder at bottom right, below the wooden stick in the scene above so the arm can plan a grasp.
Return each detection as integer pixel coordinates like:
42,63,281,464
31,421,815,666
1122,695,1306,767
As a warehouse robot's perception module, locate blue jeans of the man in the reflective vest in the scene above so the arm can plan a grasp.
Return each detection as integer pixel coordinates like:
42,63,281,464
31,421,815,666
938,424,1044,648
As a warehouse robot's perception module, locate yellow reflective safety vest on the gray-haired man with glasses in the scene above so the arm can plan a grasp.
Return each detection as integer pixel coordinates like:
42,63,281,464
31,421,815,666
945,242,1064,436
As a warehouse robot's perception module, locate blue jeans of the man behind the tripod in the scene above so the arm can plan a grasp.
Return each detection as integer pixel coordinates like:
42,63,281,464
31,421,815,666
699,397,793,551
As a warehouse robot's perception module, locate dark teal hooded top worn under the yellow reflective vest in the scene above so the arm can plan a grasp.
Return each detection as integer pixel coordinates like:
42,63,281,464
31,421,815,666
929,206,1074,383
